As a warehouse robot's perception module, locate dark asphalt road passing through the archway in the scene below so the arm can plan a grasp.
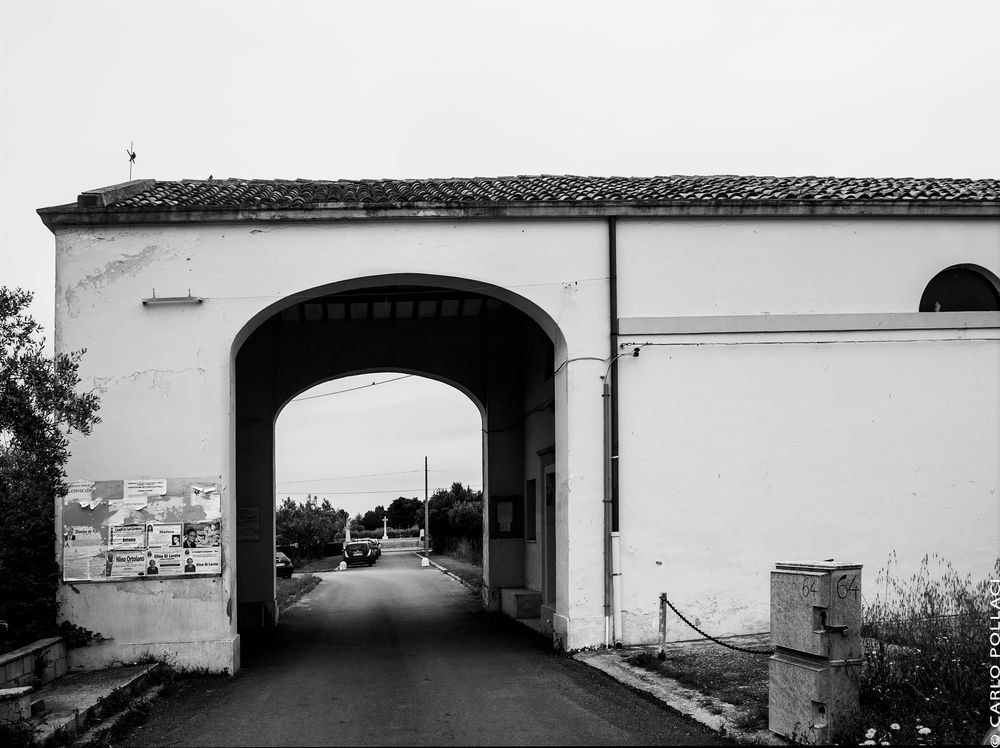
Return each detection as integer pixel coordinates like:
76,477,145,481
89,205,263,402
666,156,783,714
125,553,725,746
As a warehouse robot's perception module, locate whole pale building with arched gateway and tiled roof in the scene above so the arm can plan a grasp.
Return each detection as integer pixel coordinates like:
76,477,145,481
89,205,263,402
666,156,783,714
39,177,1000,671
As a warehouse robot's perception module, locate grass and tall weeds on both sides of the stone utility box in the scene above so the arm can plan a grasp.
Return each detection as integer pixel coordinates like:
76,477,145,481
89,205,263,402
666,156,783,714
627,556,1000,745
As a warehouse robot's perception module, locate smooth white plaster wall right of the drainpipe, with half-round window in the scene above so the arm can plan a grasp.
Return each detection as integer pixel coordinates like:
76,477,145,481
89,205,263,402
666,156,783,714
619,220,1000,641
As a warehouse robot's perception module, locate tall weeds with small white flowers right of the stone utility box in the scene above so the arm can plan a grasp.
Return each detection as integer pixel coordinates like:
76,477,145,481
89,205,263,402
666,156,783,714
847,553,1000,745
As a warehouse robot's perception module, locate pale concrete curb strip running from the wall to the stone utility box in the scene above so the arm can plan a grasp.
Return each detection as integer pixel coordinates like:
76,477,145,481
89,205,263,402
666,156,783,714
571,650,790,746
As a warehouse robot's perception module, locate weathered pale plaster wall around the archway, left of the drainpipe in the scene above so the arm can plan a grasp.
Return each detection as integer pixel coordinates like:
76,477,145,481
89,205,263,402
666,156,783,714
55,216,609,671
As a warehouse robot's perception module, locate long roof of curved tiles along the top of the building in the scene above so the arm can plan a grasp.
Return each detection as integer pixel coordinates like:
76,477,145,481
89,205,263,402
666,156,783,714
103,175,1000,211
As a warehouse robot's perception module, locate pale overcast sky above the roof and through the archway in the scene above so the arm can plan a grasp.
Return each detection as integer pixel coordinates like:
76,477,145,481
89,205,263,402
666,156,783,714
0,0,1000,513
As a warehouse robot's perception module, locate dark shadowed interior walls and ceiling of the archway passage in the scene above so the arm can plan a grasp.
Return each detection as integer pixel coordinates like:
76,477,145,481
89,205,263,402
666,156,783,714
231,273,566,629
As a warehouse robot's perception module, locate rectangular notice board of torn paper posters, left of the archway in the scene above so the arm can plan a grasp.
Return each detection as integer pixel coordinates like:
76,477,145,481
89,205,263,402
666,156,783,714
62,477,223,582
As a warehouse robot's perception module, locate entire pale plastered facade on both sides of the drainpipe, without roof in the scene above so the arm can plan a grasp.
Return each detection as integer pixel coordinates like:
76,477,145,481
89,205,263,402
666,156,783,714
56,212,1000,670
